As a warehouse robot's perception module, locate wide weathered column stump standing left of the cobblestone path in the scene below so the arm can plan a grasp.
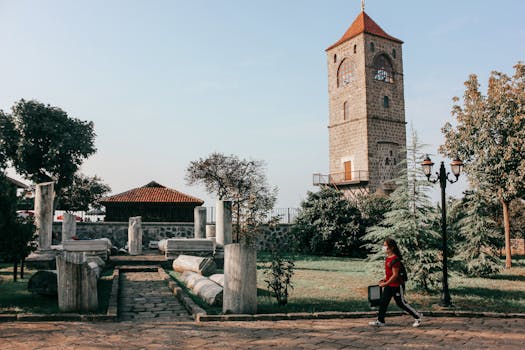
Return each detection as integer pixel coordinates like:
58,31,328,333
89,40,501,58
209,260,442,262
57,251,100,312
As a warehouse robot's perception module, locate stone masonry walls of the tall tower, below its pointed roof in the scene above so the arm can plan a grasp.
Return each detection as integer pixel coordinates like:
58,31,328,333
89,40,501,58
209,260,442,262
327,14,406,192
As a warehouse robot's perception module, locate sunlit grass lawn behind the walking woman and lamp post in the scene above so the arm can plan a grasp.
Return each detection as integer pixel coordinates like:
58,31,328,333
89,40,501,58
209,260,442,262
170,256,525,314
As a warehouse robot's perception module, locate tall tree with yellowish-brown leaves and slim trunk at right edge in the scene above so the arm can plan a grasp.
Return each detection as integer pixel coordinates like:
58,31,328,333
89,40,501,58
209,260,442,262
440,62,525,268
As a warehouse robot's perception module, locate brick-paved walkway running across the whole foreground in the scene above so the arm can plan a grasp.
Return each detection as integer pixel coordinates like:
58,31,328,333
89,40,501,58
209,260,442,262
0,316,525,350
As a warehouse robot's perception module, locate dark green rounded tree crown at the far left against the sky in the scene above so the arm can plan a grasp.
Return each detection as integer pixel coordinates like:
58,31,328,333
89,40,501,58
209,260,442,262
2,99,96,200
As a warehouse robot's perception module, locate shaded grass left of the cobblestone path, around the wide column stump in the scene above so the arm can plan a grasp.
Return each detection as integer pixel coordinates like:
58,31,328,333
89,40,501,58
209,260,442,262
0,263,113,314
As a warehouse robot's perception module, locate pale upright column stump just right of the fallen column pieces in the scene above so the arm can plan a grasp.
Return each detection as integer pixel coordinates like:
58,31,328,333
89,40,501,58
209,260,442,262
222,243,257,314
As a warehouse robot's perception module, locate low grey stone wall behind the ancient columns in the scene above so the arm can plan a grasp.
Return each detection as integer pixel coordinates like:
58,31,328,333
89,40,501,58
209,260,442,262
53,222,291,250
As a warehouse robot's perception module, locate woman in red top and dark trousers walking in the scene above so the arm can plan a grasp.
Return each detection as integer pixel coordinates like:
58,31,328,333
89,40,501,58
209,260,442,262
369,238,423,327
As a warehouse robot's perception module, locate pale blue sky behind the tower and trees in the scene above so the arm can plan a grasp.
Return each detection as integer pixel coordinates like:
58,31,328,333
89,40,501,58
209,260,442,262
0,0,525,207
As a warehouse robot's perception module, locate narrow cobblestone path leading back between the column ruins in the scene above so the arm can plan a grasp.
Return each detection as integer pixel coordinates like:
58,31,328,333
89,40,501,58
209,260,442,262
118,271,193,322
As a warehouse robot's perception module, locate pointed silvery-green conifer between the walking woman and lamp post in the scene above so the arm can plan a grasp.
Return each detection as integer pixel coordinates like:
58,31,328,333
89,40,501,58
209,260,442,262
364,132,441,291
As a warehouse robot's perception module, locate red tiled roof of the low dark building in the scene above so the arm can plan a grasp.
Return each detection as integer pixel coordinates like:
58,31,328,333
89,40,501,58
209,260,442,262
100,181,204,204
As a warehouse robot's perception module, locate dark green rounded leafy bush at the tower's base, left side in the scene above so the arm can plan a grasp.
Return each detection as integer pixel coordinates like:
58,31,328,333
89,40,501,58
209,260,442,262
292,187,364,256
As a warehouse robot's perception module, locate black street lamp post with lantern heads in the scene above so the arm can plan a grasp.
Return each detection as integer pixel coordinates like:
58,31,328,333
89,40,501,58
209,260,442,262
421,155,463,307
